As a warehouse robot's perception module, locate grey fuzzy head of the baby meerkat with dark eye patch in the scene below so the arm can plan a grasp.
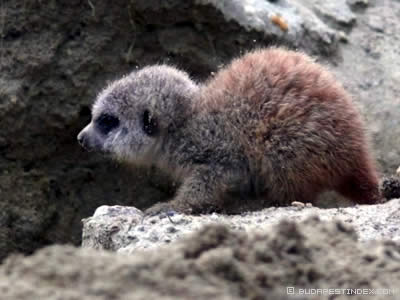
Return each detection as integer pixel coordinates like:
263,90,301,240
78,65,198,163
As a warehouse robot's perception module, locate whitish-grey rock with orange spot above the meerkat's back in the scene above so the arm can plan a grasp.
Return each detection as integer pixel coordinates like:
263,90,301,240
202,0,340,54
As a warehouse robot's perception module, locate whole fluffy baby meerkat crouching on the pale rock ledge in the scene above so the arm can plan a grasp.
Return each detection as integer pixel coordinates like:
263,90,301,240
78,48,381,214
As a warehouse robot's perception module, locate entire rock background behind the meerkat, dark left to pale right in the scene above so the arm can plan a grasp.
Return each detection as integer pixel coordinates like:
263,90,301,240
0,0,400,260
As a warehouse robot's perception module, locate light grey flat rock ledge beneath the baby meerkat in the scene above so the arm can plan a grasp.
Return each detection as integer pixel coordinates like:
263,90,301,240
82,199,400,253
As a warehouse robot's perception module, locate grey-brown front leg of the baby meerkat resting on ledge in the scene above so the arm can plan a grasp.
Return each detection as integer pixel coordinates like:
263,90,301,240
145,166,238,215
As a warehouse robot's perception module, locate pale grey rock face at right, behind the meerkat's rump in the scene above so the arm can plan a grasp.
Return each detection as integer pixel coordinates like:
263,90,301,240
332,1,400,174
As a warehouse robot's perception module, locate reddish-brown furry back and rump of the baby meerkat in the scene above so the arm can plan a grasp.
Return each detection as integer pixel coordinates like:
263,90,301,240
203,48,381,205
